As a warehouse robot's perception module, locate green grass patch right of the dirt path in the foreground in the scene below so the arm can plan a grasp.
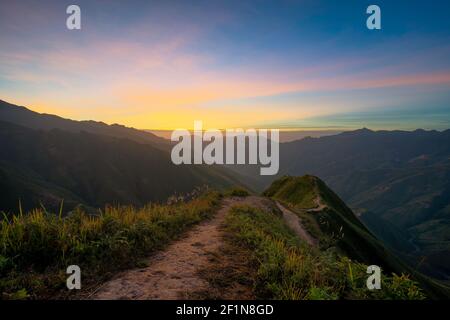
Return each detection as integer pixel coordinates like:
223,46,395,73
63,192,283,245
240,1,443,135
225,206,425,300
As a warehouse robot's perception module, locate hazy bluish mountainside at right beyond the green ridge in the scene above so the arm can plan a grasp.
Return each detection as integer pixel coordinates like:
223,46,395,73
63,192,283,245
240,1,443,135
231,129,450,280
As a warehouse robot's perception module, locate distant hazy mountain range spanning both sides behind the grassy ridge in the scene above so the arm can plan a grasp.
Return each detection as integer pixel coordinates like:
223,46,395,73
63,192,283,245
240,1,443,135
0,101,450,281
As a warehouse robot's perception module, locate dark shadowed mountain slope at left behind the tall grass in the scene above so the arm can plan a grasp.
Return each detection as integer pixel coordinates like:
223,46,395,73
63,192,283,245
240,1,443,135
0,103,244,212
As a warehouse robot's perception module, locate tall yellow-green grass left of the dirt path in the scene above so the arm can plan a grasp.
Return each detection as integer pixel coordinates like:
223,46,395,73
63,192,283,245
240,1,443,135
0,192,220,299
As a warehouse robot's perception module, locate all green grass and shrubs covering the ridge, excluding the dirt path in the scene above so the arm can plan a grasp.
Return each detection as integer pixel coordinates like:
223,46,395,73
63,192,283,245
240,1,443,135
0,172,446,300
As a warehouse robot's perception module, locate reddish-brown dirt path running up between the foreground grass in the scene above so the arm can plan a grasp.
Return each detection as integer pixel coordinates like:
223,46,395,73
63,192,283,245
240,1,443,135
93,197,253,300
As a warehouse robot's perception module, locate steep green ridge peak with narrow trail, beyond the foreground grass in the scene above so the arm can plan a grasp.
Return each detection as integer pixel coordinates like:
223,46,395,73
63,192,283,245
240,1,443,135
264,175,449,298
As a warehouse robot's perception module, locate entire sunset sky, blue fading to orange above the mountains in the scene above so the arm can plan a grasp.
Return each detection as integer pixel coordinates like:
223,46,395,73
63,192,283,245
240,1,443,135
0,0,450,130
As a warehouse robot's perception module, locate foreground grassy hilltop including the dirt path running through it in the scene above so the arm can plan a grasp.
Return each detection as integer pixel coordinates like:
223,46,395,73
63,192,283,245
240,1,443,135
0,185,435,300
